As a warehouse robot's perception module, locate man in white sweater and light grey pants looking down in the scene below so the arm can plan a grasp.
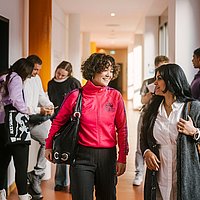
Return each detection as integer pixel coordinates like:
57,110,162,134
24,55,54,199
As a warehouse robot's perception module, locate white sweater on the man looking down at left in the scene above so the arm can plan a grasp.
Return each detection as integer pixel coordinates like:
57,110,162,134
24,75,53,114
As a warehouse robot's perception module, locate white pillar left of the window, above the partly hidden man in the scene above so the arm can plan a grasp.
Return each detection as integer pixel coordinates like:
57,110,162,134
144,16,159,79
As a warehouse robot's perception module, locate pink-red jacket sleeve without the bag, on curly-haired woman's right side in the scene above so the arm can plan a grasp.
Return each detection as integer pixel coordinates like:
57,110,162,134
115,94,129,164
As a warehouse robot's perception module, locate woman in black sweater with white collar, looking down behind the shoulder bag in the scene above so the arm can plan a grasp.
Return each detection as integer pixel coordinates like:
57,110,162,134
48,61,81,191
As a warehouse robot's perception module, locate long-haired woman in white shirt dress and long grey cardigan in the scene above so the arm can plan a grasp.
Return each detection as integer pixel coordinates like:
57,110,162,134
140,64,200,200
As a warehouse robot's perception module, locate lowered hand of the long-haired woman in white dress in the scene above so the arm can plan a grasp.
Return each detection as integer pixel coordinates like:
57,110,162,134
144,150,160,171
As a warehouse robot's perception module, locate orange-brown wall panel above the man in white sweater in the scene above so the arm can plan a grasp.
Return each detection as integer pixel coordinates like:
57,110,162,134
29,0,52,90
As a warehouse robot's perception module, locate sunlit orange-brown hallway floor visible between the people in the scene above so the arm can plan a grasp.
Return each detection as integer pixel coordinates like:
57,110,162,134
8,102,143,200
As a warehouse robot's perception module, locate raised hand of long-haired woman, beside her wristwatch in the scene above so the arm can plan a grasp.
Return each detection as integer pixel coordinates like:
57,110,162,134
177,116,196,136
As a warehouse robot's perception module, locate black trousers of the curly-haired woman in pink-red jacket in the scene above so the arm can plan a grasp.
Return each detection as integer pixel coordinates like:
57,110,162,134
70,146,117,200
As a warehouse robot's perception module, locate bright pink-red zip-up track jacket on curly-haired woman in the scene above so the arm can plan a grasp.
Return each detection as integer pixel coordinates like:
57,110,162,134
46,81,128,163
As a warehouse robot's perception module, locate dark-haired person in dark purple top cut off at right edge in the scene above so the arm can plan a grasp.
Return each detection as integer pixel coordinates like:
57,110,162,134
191,48,200,100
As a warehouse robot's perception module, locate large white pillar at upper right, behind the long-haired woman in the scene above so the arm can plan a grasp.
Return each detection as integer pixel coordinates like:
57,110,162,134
169,0,200,83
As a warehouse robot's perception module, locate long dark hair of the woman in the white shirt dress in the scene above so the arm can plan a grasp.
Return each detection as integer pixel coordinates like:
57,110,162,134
141,64,194,141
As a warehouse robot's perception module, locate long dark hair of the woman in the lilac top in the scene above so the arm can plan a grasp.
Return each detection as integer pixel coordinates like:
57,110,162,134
4,58,34,95
